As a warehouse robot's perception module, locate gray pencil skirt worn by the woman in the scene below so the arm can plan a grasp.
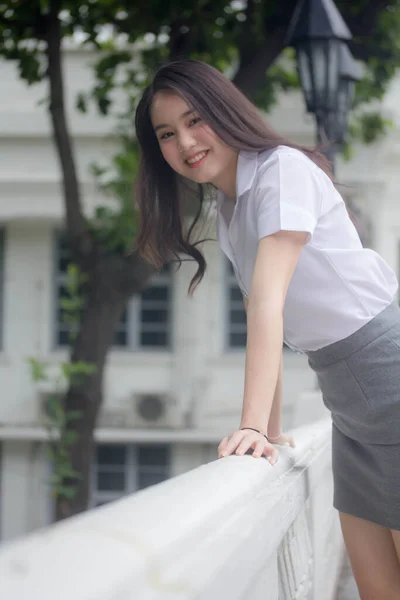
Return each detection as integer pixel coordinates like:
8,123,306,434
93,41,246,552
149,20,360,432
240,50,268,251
307,303,400,530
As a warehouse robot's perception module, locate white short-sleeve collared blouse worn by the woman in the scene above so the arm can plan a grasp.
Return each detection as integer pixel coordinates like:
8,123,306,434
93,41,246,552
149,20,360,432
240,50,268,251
217,146,398,352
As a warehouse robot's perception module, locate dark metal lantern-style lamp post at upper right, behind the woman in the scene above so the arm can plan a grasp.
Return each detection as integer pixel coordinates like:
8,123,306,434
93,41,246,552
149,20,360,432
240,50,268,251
286,0,361,169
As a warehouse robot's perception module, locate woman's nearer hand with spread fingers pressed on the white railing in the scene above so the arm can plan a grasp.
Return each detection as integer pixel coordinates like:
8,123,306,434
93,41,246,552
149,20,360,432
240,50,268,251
218,429,278,465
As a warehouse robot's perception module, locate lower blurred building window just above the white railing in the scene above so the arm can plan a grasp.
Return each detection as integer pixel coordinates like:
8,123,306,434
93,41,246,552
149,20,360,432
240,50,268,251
91,444,171,507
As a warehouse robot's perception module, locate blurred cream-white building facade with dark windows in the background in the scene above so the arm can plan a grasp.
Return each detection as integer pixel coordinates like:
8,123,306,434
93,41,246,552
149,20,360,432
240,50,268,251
0,50,400,540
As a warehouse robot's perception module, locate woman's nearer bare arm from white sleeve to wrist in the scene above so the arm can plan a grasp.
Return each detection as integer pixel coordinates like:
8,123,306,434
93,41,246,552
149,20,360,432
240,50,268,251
240,231,308,433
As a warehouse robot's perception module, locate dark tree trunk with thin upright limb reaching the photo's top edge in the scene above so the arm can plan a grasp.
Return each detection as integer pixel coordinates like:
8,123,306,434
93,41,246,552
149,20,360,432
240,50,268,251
45,0,154,520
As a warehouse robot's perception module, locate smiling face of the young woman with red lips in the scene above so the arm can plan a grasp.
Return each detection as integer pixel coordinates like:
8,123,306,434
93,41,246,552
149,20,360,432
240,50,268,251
151,92,238,198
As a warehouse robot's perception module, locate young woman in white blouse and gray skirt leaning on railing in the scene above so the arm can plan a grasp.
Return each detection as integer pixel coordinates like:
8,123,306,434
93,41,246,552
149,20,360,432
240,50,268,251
135,60,400,600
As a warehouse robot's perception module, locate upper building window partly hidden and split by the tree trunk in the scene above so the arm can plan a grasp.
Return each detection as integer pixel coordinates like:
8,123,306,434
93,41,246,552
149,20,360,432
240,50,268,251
55,234,172,350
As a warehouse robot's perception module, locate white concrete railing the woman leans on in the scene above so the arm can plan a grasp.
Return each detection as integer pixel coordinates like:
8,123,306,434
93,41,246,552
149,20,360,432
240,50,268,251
0,421,343,600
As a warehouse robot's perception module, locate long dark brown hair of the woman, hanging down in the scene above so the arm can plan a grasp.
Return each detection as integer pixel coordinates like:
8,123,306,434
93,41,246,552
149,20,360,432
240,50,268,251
134,59,331,295
